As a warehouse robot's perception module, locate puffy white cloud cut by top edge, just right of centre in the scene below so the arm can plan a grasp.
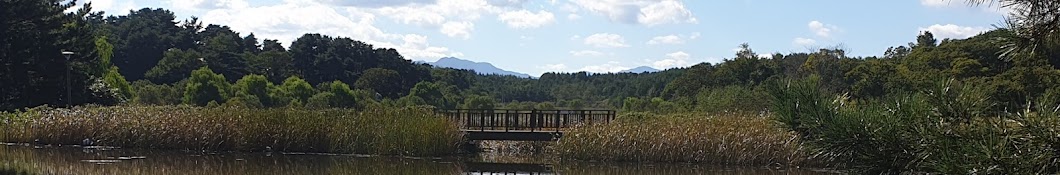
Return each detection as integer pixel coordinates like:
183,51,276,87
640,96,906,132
572,0,696,27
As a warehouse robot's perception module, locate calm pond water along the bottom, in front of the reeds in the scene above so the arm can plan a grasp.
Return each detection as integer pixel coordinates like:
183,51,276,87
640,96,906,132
0,145,822,175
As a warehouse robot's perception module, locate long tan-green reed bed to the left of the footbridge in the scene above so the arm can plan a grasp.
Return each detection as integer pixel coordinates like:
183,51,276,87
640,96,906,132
0,106,462,156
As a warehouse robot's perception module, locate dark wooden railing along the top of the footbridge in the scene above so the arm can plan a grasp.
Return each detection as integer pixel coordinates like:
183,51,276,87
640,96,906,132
439,109,616,132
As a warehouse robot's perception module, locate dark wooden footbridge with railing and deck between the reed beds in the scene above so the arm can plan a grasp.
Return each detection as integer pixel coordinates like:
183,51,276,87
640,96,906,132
440,109,615,141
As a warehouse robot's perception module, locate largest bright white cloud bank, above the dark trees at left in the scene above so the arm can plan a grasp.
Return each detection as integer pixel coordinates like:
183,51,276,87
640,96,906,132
200,1,462,59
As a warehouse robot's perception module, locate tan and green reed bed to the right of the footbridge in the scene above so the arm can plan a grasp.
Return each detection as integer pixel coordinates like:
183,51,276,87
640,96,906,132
554,113,809,167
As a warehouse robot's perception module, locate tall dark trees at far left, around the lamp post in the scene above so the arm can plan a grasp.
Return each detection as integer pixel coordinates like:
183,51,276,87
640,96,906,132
0,0,124,110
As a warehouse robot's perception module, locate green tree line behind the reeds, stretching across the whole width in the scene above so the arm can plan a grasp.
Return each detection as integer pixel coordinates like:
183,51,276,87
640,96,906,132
0,0,1060,111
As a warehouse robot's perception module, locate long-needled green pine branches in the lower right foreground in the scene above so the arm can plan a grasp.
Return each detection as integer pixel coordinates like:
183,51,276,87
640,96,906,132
769,78,1060,174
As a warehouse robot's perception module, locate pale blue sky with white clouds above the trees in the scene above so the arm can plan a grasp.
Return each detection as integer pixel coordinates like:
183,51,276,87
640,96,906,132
72,0,1008,75
